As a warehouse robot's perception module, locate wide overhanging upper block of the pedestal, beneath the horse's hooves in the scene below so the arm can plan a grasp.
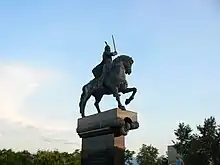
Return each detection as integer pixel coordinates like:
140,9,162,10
77,108,139,138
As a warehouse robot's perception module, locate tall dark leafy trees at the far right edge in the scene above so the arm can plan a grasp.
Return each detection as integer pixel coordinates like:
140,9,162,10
173,117,220,165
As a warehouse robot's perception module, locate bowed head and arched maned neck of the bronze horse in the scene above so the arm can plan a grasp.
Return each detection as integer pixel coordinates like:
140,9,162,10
113,55,134,75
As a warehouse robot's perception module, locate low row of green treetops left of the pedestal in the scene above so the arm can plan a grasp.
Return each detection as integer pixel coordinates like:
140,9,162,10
0,149,80,165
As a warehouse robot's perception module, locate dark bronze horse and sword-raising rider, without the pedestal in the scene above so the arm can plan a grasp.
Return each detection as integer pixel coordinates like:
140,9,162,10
79,37,137,117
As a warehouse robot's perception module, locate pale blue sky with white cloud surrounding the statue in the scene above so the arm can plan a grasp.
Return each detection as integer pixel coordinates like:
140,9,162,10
0,0,220,153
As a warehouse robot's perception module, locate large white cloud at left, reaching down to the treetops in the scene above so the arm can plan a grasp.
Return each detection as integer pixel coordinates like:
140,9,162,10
0,63,80,152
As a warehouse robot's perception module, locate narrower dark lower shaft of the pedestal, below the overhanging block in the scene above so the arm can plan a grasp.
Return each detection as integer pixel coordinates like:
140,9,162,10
81,134,125,165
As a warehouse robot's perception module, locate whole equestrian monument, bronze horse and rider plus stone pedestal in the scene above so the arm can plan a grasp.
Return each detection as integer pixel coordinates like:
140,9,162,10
77,36,139,165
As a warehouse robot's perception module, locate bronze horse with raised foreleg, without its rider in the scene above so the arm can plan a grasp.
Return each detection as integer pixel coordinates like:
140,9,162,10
79,55,137,117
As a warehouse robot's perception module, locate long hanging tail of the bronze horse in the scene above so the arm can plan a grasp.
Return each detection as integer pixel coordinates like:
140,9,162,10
79,81,93,115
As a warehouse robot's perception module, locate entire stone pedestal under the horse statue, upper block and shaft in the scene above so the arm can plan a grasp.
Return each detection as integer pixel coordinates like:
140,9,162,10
77,108,139,165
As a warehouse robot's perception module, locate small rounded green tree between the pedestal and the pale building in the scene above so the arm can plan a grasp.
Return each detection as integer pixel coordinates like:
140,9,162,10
136,144,159,165
